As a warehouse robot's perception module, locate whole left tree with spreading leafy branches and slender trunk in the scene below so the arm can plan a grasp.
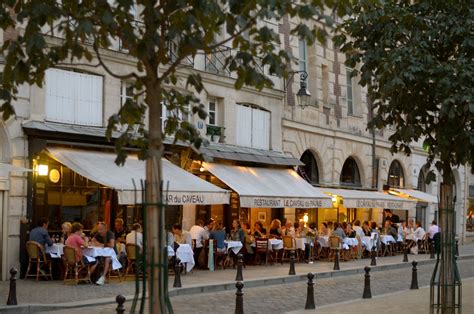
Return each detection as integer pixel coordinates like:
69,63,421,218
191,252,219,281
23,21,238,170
0,0,350,313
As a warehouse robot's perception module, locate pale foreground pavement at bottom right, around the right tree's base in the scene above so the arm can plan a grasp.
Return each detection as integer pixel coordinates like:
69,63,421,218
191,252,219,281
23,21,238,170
289,278,474,314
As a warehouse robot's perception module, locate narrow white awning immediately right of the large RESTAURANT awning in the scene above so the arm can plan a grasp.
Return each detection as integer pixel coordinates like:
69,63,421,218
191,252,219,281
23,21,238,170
321,188,416,210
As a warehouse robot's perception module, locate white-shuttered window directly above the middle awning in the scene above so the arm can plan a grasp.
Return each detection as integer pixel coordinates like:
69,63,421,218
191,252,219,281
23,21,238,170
236,104,270,149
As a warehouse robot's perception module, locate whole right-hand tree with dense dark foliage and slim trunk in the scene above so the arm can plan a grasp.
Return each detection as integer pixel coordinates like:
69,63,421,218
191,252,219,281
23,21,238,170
335,0,474,313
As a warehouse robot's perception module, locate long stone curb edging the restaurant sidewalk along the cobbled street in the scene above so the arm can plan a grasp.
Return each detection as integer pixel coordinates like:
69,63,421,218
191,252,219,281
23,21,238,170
0,255,474,314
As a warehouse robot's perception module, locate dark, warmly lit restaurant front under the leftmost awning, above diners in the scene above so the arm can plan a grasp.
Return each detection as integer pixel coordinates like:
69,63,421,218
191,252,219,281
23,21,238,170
32,152,142,232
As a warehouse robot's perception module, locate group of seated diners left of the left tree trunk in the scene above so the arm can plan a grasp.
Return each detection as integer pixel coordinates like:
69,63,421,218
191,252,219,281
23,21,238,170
29,218,143,285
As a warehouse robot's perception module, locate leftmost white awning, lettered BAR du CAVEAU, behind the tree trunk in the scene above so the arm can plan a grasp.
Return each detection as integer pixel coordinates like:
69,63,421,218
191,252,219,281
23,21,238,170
48,147,229,205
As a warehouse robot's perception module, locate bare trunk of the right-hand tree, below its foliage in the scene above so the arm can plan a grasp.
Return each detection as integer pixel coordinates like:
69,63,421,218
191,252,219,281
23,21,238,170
439,183,456,314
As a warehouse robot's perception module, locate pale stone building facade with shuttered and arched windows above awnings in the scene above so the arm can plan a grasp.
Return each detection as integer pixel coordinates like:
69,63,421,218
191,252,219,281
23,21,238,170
0,13,467,280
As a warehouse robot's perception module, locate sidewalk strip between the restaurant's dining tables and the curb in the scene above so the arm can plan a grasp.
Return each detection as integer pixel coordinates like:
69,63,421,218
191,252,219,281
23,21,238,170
0,244,474,312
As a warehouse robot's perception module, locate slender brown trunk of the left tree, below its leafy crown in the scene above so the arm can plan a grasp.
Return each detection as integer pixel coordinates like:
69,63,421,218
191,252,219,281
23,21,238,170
145,84,168,313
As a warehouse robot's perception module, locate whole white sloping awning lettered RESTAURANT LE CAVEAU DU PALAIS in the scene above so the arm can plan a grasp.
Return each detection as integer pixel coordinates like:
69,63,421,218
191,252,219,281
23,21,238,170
203,163,332,208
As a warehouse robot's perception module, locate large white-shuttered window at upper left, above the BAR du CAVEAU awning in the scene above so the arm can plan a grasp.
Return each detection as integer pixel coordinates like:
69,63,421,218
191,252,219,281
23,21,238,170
45,69,103,126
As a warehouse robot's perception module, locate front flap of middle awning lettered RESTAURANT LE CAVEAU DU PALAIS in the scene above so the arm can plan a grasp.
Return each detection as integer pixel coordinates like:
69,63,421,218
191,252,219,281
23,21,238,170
240,196,332,208
